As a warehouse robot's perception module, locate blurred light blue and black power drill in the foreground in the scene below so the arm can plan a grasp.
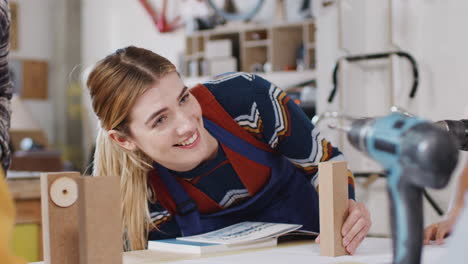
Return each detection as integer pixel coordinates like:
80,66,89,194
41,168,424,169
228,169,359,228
347,112,459,264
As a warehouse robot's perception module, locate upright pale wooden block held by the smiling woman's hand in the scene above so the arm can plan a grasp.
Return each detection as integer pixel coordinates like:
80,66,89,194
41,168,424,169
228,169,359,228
319,161,348,257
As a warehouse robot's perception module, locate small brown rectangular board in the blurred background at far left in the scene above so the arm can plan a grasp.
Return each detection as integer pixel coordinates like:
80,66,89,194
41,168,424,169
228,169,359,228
21,60,48,99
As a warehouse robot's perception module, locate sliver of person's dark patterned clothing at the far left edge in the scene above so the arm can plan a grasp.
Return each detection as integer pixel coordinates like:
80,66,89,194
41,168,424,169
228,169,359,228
0,0,12,170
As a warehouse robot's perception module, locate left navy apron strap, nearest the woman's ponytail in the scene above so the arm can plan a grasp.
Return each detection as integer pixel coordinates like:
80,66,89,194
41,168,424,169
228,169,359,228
153,162,202,236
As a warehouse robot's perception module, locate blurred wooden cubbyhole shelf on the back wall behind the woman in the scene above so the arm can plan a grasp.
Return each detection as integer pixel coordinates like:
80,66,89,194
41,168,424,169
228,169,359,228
181,20,315,76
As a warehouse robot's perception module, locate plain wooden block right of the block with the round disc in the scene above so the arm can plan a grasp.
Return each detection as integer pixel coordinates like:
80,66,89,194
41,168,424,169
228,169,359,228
78,176,123,264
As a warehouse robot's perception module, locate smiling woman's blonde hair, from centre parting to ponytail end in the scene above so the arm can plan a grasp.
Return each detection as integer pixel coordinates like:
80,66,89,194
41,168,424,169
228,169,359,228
87,46,176,250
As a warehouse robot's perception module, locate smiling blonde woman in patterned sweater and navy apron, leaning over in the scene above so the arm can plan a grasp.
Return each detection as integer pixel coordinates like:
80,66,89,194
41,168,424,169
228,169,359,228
87,47,370,253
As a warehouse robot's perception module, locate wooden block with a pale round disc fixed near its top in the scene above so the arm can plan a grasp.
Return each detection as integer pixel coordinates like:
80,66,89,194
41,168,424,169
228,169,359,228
41,172,80,264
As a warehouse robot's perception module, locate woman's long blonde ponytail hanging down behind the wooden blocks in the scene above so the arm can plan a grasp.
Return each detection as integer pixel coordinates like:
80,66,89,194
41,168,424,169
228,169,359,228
93,128,152,251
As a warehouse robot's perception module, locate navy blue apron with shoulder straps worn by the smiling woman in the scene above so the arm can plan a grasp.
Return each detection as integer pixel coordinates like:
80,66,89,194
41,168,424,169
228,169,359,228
154,118,319,236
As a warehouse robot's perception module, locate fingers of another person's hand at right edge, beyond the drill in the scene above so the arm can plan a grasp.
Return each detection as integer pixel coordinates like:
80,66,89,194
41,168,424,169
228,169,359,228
423,208,460,245
